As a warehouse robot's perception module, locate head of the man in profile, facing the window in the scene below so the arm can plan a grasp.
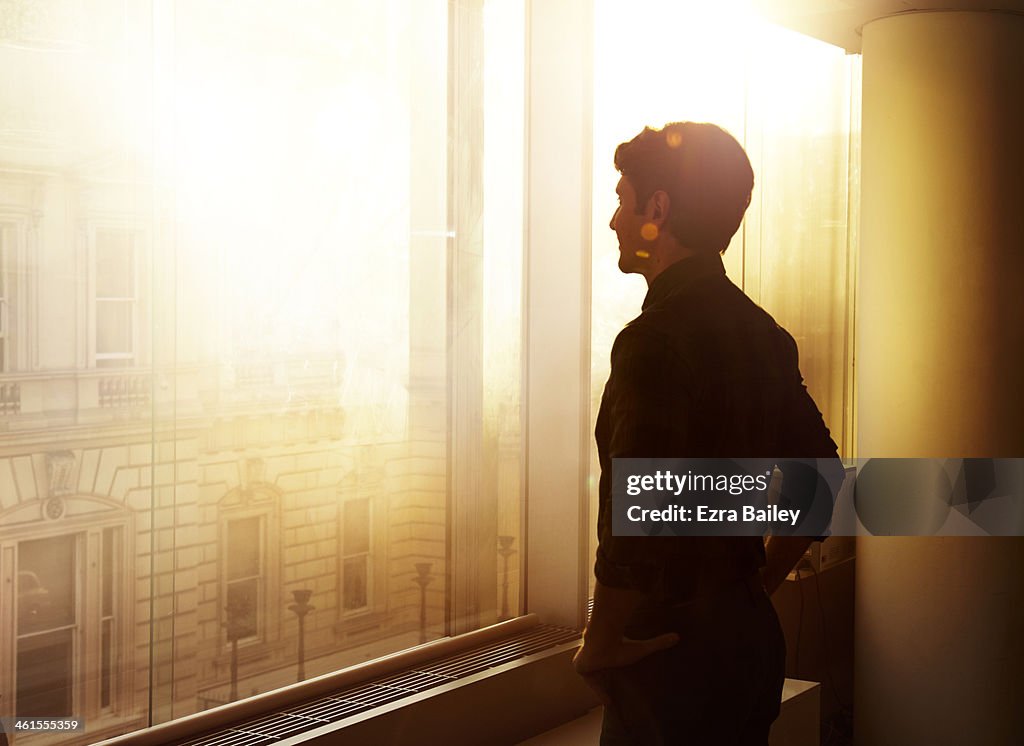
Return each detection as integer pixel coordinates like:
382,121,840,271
610,122,754,280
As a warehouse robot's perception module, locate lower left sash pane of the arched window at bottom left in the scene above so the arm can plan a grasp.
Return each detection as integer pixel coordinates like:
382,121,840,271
15,629,77,717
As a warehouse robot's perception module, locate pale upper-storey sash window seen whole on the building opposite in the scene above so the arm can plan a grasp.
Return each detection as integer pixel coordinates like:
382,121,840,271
94,228,138,367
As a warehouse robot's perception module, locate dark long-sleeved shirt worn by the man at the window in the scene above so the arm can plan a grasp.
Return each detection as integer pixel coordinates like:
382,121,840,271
594,254,842,602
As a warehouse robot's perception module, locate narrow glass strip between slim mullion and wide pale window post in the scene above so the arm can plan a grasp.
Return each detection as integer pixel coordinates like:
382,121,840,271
483,0,527,621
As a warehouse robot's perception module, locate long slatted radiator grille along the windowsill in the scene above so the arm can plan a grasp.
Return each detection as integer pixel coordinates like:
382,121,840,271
175,624,580,746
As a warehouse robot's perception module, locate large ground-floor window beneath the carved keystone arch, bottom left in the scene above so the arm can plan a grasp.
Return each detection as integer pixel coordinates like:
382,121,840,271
14,527,122,717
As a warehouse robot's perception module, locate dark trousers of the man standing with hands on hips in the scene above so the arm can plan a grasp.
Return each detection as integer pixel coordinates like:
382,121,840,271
601,581,785,746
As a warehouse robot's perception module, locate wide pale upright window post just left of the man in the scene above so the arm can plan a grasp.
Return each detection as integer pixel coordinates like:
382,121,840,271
521,0,593,629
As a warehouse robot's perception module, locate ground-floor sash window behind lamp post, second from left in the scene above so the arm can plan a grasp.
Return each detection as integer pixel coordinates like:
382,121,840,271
222,516,266,642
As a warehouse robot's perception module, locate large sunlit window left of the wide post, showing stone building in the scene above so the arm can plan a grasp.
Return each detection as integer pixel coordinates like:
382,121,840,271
0,0,525,743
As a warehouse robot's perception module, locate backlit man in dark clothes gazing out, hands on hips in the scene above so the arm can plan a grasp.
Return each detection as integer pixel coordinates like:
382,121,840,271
574,122,842,746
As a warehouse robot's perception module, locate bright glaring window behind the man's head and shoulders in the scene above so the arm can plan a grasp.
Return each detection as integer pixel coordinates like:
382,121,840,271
591,0,860,589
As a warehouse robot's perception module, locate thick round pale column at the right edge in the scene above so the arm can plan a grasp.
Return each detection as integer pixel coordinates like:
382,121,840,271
854,11,1024,746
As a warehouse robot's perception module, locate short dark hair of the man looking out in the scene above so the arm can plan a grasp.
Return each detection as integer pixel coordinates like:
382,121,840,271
615,122,754,252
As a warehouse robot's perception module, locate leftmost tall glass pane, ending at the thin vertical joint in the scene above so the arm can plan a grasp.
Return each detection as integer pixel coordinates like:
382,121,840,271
0,0,155,732
